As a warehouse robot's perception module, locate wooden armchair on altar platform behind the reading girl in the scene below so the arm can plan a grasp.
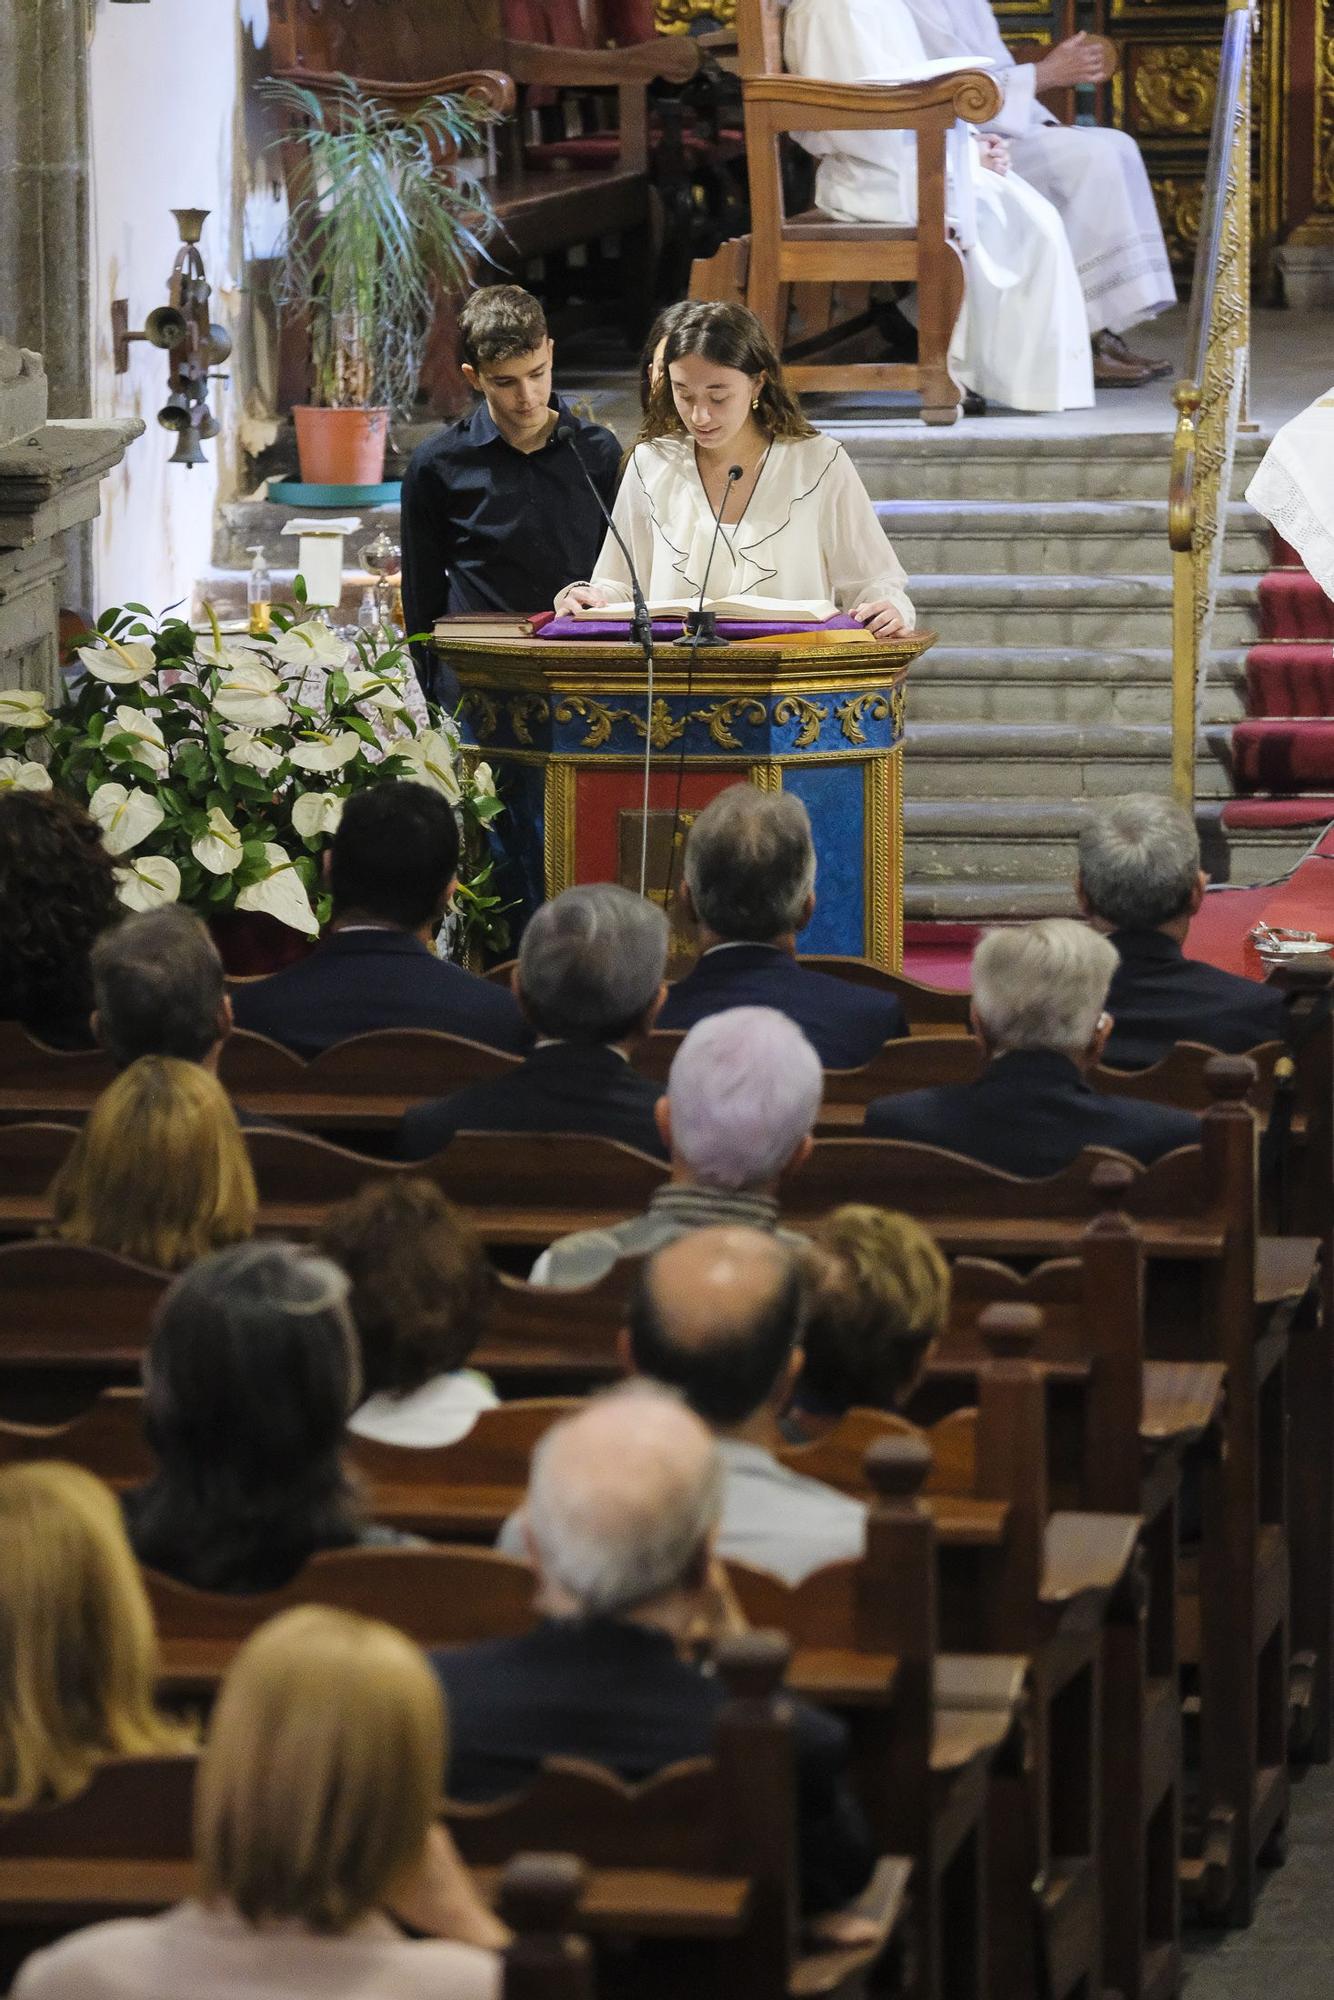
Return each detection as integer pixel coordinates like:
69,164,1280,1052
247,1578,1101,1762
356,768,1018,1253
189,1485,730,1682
690,0,1000,424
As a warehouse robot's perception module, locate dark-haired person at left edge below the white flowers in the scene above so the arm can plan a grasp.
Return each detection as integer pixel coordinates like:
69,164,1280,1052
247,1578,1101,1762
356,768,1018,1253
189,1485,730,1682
0,788,120,1048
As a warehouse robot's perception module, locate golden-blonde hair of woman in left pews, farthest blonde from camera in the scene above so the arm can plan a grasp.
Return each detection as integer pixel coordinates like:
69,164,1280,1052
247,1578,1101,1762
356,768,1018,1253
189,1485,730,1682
50,1056,258,1270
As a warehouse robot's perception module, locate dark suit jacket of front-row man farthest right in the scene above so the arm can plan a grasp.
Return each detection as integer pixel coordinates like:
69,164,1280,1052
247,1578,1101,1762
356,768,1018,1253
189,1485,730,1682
1102,930,1288,1070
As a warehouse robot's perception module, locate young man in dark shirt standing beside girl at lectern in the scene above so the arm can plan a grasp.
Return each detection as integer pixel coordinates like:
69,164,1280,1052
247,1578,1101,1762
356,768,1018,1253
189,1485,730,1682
402,284,620,700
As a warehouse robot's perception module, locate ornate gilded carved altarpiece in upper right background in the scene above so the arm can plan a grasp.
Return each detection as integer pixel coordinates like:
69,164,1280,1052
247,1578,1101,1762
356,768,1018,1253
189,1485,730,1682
656,0,1334,290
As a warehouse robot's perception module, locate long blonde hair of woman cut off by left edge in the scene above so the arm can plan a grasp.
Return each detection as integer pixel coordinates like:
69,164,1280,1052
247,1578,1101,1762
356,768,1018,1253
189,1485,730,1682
0,1462,188,1810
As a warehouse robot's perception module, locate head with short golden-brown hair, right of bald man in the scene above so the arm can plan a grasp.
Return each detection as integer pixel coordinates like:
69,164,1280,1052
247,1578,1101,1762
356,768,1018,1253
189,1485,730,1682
784,1202,950,1444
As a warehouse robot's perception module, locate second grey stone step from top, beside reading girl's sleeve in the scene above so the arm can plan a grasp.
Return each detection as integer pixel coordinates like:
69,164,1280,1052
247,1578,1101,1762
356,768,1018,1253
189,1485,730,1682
876,500,1270,578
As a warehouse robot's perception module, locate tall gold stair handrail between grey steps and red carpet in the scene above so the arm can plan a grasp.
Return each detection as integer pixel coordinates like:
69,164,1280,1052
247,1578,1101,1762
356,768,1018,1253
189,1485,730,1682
1168,0,1256,810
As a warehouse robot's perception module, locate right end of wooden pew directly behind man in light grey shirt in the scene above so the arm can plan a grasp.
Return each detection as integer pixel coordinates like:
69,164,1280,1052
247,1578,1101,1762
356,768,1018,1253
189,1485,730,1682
730,1436,1026,2000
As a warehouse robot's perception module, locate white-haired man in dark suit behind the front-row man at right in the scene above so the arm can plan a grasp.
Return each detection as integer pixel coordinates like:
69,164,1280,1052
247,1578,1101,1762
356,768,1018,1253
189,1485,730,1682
866,916,1200,1176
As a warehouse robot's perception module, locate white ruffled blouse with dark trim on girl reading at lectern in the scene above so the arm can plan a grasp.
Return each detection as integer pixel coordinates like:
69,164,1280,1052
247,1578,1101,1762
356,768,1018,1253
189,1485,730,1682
590,436,916,630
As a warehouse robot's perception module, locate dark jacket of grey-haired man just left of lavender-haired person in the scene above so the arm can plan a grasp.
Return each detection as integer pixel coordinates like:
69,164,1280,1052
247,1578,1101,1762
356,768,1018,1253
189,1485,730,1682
398,1042,666,1160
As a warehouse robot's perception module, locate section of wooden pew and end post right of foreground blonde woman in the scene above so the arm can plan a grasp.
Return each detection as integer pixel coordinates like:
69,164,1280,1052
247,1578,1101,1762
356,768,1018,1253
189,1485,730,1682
446,1634,910,2000
